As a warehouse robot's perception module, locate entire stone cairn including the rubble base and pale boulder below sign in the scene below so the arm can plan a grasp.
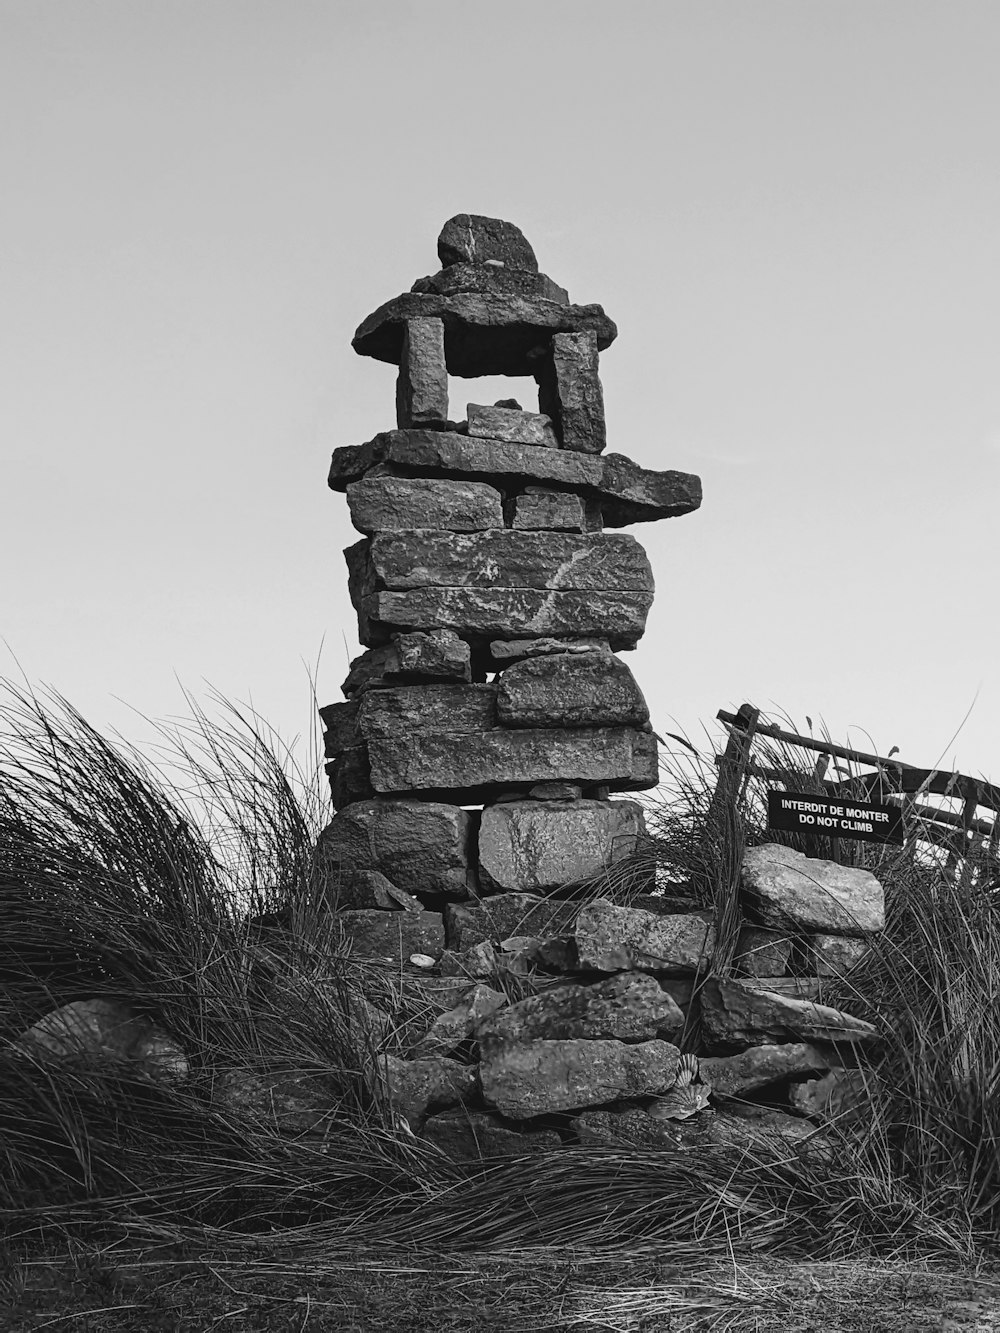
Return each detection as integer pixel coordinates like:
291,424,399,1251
305,213,883,1156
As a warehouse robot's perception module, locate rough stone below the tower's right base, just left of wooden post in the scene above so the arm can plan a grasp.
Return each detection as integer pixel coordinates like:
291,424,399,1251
575,898,715,973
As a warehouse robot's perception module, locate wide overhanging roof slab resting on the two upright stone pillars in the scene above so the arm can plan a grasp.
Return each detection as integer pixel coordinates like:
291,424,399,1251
351,289,619,377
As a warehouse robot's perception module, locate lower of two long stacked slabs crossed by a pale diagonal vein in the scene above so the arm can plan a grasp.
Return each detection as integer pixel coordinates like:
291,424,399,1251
355,586,653,652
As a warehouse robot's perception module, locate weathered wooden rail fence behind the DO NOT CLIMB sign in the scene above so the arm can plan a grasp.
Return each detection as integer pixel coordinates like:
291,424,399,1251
713,704,1000,869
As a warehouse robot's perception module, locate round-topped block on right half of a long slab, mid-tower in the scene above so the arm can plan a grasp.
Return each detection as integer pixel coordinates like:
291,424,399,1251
496,652,649,726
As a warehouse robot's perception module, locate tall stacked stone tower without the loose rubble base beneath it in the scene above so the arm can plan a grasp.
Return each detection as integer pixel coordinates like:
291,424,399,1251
321,213,701,938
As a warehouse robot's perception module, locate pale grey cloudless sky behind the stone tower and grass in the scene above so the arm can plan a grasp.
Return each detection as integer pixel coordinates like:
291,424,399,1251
0,0,1000,778
